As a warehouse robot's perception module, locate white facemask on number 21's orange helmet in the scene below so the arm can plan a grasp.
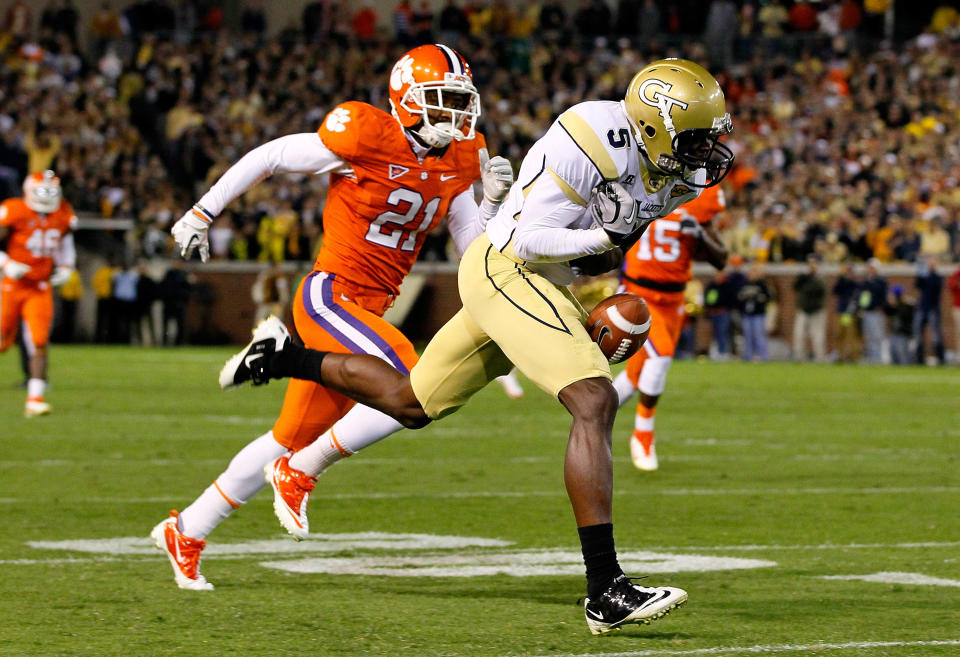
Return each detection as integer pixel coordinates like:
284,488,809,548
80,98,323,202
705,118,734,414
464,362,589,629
400,73,480,148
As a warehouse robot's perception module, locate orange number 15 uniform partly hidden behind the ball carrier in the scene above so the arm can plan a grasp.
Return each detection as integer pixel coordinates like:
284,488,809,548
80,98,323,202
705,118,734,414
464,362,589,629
621,185,726,395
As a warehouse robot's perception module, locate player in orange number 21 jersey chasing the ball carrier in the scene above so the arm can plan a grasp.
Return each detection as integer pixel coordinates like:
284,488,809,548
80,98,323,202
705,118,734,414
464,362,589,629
151,44,513,590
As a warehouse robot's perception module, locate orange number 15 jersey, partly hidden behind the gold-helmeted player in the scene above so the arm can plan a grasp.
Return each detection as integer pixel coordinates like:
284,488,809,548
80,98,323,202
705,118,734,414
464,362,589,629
623,185,727,291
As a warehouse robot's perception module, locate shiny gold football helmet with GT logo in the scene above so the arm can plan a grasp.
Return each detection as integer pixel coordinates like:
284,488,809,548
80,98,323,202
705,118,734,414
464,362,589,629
621,59,733,187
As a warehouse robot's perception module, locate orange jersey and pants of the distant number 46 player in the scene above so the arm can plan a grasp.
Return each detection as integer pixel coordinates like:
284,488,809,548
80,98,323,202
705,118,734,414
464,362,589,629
0,198,77,353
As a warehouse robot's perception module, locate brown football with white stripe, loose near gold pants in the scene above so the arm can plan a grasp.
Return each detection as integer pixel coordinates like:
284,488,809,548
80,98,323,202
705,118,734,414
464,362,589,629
587,294,650,364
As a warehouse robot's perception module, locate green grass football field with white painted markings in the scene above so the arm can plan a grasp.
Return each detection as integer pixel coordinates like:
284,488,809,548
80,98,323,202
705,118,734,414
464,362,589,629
0,346,960,657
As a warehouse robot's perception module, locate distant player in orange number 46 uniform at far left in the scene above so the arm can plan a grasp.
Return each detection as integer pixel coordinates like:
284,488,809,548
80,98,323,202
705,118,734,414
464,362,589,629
0,171,77,417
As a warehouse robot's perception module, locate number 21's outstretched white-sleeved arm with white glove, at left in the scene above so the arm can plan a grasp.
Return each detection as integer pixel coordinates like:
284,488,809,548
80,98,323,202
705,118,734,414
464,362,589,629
170,132,346,262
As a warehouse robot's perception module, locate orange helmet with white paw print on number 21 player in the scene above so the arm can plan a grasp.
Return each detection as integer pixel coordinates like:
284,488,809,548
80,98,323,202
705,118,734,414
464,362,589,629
390,43,480,148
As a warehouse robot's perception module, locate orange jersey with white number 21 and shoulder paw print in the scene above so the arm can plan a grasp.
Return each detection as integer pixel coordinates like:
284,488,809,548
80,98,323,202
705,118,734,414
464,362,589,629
314,102,486,294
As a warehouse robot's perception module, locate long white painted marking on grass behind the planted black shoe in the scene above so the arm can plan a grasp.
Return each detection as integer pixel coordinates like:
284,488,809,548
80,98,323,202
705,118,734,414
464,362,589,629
260,549,777,577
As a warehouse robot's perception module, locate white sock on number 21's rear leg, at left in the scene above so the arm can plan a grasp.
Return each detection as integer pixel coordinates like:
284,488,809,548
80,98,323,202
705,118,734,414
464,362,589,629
180,431,287,539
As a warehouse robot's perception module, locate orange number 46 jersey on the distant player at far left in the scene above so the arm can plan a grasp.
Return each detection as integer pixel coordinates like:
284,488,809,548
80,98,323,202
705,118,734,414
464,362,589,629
0,198,77,282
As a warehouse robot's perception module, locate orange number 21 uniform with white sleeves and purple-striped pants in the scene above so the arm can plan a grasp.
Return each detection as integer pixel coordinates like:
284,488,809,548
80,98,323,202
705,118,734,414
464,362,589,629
194,102,495,450
